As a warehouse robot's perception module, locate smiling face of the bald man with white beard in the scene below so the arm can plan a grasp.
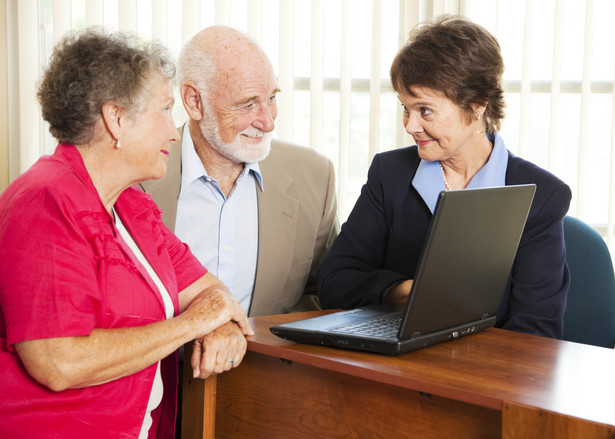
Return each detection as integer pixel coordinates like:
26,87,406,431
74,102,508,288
199,56,279,163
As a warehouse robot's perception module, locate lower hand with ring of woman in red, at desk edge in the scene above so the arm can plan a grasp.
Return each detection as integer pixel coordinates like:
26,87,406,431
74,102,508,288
190,322,248,379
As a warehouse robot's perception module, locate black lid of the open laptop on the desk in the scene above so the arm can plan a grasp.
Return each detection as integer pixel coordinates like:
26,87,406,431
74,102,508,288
399,184,536,339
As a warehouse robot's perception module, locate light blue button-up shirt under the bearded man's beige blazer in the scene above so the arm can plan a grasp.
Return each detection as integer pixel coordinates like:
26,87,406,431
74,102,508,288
175,126,263,313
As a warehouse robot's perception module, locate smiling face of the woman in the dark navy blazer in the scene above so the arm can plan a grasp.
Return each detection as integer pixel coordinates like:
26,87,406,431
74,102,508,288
398,87,484,161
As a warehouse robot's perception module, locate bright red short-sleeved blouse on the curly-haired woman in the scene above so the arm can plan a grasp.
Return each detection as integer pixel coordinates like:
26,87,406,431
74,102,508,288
0,145,207,438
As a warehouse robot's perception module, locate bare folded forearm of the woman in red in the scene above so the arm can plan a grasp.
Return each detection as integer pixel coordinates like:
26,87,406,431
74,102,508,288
15,273,253,391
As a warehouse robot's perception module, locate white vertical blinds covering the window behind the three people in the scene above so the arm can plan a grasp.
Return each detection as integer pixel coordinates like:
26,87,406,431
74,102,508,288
3,0,615,254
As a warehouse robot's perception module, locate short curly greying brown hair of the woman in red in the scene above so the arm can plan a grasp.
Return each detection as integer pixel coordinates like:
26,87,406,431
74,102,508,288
37,28,175,145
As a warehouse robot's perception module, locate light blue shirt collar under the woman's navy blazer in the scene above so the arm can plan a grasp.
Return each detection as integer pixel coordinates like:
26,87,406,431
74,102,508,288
412,133,508,213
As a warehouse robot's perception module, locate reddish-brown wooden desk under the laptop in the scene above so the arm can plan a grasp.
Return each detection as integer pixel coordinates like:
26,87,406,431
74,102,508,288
182,312,615,439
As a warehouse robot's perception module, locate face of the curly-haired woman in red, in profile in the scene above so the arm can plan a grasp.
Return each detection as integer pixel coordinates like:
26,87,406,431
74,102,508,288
120,76,179,182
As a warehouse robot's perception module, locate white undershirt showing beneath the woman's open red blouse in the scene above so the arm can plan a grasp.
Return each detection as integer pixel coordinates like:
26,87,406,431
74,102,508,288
113,210,175,439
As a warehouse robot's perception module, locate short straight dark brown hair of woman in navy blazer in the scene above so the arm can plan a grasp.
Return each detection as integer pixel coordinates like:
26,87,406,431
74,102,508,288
391,15,504,133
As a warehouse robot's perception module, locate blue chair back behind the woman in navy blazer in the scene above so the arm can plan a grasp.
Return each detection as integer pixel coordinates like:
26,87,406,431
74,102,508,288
563,216,615,348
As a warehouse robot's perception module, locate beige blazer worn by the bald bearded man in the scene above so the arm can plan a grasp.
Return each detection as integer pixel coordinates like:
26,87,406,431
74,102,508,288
141,130,339,316
